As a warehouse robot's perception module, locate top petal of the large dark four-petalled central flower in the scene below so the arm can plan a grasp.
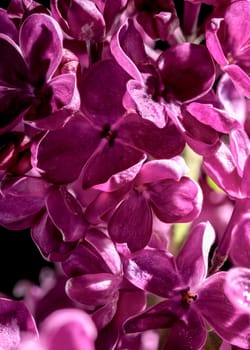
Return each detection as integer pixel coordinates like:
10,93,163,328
79,59,129,126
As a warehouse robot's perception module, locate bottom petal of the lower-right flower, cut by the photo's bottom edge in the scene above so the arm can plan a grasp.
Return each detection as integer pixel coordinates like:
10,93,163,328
164,310,207,350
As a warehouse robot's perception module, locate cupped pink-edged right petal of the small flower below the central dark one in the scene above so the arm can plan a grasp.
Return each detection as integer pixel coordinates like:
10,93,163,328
147,177,202,223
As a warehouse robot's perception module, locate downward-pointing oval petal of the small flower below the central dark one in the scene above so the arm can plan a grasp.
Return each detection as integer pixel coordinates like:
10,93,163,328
108,191,152,251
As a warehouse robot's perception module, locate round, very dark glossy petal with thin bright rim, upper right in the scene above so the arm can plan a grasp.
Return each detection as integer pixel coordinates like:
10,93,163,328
158,43,215,102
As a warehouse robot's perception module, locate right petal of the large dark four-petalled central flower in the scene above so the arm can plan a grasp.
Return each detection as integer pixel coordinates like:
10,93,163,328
118,114,185,159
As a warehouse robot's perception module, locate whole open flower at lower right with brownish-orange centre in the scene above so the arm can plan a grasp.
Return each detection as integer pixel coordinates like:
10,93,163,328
124,223,250,349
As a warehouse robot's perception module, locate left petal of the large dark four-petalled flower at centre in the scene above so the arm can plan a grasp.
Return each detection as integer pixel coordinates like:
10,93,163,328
33,116,100,183
